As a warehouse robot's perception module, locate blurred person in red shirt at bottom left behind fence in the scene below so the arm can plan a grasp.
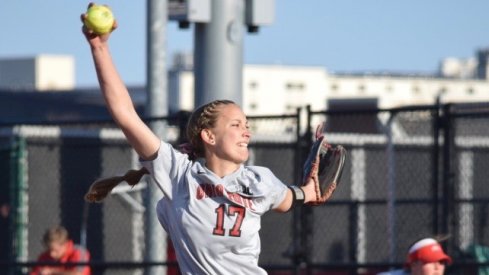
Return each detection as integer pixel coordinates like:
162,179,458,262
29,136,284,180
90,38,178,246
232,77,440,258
30,226,91,275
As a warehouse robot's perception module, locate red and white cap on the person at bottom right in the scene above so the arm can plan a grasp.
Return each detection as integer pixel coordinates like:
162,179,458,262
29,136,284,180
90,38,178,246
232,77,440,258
406,238,452,265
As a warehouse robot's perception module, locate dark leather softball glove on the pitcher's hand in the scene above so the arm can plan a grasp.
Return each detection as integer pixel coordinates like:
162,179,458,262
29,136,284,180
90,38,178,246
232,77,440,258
303,126,346,205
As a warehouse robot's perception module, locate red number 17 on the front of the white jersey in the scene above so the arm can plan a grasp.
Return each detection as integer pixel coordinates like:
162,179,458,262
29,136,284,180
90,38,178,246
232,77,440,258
212,204,246,237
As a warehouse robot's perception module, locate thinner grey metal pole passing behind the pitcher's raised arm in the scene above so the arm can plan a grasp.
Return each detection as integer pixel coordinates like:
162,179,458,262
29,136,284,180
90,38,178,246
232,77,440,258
145,0,168,275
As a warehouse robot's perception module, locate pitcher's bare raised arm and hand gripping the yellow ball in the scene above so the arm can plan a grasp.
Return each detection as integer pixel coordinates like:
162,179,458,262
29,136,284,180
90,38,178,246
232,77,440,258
81,5,160,159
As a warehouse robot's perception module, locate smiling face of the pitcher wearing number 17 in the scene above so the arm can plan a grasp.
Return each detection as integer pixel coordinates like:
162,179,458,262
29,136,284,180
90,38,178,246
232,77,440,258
212,104,251,164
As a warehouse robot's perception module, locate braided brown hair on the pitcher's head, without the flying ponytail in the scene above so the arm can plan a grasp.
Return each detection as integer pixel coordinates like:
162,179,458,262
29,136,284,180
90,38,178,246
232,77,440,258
187,100,236,160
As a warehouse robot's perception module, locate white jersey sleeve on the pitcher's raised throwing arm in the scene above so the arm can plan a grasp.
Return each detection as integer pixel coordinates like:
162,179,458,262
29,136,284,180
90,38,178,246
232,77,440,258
140,141,191,200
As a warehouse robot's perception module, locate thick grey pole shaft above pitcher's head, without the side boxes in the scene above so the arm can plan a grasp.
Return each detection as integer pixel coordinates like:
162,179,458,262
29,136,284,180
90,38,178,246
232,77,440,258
194,0,245,107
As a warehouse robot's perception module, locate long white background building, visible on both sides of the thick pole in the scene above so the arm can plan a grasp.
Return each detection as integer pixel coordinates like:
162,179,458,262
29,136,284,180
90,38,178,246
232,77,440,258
169,65,489,115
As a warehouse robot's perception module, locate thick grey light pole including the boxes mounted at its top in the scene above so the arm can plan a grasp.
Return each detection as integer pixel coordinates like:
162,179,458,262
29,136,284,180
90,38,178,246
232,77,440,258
169,0,275,107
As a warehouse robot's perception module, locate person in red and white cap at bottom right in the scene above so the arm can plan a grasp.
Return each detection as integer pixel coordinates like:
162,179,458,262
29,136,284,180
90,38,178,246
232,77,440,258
378,238,452,275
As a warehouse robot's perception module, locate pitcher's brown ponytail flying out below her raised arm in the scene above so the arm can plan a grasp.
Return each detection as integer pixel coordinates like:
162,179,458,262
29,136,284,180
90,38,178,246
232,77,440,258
85,167,149,202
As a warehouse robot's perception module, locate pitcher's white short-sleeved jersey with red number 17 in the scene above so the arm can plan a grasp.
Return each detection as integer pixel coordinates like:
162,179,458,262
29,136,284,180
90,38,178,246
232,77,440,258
142,142,287,275
